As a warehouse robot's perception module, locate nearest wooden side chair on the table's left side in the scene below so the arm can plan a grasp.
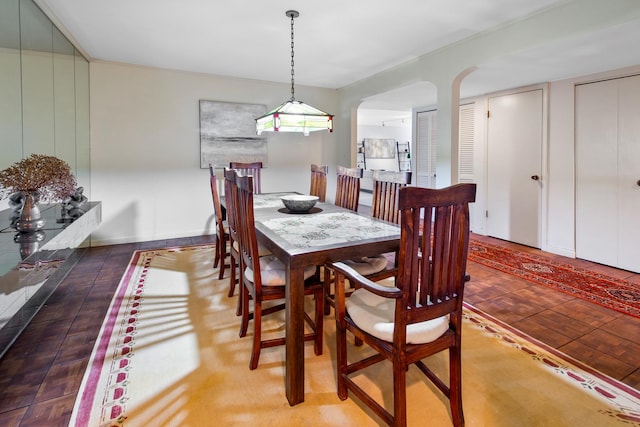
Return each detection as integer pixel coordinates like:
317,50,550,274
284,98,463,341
236,172,324,370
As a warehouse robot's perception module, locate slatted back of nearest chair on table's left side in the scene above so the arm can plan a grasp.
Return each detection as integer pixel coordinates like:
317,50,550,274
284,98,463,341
236,175,262,293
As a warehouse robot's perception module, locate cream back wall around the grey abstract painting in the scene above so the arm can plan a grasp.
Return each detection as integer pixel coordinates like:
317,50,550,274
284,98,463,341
91,62,344,245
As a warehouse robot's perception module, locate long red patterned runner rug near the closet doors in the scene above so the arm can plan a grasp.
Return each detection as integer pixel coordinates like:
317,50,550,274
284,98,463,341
469,239,640,317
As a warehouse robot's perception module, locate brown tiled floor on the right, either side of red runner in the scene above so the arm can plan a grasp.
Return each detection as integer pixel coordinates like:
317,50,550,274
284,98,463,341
465,236,640,389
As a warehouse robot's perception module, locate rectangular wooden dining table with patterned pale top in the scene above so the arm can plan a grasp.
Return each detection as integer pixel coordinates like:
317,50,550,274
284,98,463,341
222,192,400,406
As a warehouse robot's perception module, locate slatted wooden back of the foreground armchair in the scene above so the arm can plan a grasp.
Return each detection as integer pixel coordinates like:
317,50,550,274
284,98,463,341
396,184,476,324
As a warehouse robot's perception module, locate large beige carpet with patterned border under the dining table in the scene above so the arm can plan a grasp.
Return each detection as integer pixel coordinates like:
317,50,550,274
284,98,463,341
70,246,640,427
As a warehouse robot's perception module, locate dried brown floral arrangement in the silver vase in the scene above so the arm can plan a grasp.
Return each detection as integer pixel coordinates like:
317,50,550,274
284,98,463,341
0,154,76,202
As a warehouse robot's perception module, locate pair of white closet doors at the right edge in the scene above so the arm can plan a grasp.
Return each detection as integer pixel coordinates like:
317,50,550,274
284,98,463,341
575,76,640,272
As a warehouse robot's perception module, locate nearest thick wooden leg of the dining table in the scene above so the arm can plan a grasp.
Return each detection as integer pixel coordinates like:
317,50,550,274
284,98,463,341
285,264,304,406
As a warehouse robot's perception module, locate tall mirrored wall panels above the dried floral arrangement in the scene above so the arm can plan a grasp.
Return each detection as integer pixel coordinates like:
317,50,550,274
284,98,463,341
0,0,91,210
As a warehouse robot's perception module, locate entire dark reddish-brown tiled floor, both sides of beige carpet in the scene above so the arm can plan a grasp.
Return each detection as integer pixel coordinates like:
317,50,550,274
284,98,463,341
0,232,640,427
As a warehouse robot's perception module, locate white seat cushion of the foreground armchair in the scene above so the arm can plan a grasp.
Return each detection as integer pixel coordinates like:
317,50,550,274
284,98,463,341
346,289,449,344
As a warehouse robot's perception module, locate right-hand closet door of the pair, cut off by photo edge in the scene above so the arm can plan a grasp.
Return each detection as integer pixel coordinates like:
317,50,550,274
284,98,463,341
618,76,640,271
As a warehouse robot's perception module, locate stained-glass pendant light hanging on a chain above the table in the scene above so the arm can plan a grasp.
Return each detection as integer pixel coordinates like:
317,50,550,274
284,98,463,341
256,10,333,135
